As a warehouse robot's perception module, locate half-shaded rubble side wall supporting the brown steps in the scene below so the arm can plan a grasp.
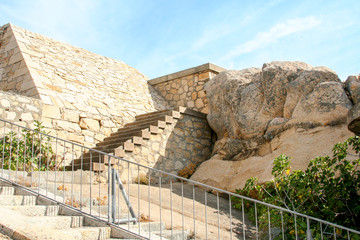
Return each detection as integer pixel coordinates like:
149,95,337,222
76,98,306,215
115,109,213,182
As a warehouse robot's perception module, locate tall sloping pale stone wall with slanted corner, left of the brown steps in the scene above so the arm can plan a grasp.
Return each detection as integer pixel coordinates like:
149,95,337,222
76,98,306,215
0,24,168,146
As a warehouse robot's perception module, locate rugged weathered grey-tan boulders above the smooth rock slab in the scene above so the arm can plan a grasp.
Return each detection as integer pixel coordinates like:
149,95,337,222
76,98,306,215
205,62,352,148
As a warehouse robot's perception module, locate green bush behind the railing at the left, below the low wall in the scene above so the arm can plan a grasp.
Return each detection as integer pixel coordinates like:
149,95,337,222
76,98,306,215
0,121,55,172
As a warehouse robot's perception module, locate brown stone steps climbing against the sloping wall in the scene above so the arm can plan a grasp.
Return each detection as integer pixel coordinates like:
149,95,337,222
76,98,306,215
72,107,186,171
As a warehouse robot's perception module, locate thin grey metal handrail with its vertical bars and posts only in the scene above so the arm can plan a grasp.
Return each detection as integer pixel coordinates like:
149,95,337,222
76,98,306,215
0,119,360,239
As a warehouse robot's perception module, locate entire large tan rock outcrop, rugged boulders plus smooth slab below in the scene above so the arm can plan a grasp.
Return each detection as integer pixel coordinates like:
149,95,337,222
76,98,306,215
192,62,360,190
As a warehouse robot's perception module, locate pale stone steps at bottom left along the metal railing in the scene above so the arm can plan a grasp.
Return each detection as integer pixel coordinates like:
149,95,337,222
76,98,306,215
0,180,188,240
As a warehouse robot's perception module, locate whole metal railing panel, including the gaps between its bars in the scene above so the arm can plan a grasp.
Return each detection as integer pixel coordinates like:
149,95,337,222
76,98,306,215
0,120,360,239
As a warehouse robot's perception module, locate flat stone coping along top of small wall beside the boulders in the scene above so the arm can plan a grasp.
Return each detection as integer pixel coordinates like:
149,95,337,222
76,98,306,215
148,63,226,85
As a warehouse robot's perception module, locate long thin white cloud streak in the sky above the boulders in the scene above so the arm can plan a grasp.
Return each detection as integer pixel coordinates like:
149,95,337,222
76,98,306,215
221,16,321,62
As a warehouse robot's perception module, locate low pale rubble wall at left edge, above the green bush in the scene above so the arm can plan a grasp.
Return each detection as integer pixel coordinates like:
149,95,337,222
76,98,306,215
0,91,43,136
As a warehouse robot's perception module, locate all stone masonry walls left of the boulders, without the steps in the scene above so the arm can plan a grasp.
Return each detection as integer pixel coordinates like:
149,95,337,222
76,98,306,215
0,24,218,170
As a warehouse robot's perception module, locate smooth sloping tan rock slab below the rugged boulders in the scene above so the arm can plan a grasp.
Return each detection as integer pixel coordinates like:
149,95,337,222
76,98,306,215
191,124,353,191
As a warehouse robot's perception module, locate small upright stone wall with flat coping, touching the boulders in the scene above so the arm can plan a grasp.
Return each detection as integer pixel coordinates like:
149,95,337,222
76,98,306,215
148,63,225,113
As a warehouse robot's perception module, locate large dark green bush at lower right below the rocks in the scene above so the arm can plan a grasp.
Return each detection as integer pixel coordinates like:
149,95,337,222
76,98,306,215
233,136,360,239
